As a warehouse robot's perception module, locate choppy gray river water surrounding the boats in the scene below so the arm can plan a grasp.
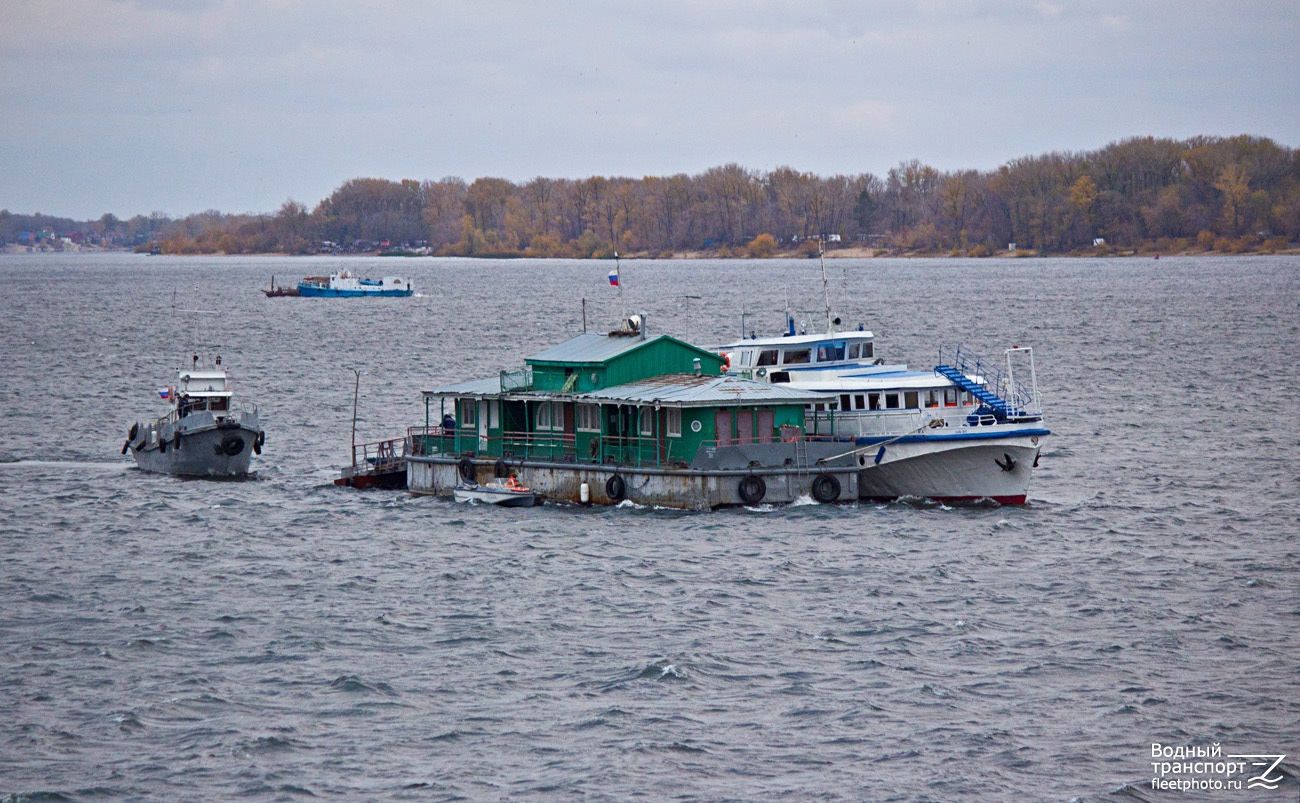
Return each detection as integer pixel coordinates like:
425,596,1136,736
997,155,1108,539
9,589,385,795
0,255,1300,800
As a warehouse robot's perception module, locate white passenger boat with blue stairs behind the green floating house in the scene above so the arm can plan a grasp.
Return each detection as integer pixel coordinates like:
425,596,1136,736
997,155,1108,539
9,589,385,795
722,318,1050,504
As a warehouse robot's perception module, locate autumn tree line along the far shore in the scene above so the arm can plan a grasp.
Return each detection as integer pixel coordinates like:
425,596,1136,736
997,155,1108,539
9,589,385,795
0,135,1300,257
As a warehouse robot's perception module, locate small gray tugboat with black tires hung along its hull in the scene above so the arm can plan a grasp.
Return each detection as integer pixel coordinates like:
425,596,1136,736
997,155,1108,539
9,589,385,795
122,353,267,478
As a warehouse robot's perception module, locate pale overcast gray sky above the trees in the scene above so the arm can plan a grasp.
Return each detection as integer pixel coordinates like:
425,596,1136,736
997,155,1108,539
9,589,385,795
0,0,1300,218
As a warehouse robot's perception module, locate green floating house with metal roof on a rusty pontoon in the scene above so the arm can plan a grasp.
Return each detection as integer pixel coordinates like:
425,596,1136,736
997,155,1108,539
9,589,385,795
407,330,857,508
